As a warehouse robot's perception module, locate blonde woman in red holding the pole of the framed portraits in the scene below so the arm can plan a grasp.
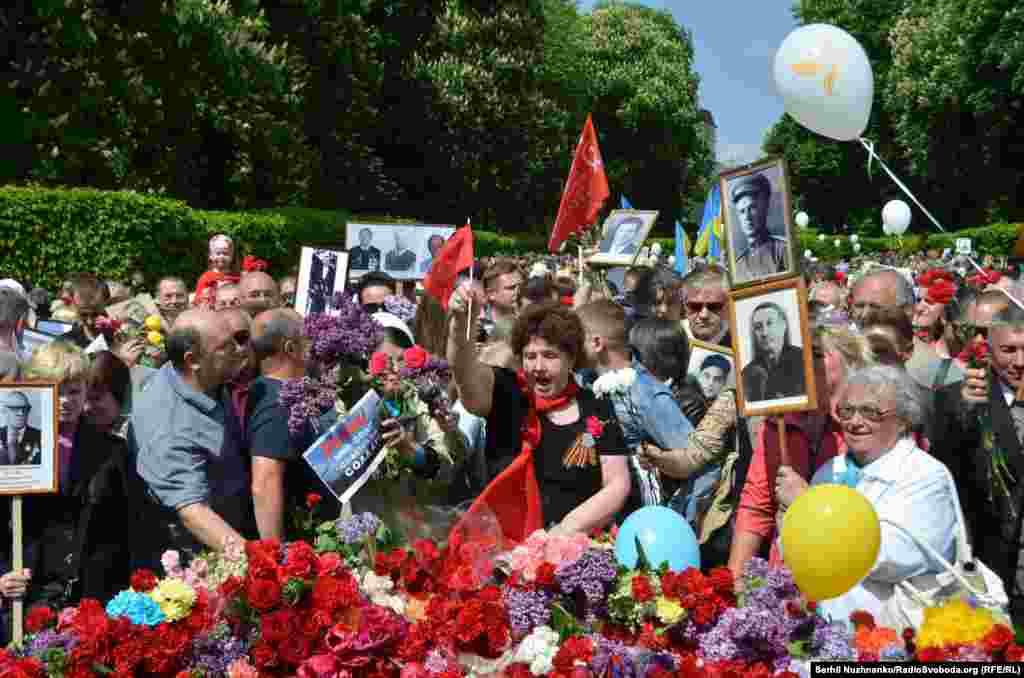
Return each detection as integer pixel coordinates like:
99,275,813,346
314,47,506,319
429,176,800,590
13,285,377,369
729,319,868,578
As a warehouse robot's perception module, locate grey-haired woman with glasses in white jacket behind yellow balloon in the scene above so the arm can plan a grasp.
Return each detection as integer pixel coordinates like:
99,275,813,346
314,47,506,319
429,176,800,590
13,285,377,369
811,366,957,623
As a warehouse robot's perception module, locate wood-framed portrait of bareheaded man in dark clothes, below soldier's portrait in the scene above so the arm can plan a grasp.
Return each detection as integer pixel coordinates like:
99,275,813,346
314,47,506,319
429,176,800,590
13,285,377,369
729,278,817,417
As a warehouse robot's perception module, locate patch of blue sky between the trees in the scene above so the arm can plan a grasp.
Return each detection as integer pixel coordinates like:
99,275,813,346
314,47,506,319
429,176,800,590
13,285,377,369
580,0,797,162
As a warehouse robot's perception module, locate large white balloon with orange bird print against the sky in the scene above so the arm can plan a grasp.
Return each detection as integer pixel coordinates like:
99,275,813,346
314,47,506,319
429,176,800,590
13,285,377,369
775,24,874,141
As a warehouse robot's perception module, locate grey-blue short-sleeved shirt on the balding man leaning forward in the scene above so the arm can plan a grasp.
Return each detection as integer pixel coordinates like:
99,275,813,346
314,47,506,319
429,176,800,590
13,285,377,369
129,363,250,509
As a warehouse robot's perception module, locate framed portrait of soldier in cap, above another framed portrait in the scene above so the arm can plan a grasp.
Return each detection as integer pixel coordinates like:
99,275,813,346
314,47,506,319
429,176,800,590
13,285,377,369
719,158,799,288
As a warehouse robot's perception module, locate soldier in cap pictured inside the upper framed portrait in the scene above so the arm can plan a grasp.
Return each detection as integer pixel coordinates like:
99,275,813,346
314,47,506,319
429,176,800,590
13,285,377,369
726,171,790,284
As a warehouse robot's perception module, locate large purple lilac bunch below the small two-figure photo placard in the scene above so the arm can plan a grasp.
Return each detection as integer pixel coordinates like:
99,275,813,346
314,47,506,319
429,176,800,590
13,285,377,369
305,292,383,368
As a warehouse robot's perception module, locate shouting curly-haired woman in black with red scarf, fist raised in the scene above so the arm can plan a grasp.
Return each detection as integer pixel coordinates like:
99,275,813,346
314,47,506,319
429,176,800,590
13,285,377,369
447,287,630,541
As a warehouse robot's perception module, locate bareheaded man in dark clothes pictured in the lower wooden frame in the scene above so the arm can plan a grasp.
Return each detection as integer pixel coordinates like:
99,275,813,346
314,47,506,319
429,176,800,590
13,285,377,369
742,301,807,402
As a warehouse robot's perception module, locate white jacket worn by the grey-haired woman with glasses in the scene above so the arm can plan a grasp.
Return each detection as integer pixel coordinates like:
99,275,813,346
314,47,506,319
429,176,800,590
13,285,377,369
811,438,957,622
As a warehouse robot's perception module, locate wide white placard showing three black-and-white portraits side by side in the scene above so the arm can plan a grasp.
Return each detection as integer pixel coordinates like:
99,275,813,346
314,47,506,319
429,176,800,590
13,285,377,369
345,223,455,281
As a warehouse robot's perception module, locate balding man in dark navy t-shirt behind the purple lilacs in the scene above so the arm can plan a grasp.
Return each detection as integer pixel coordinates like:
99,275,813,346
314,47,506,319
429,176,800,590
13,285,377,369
246,308,321,540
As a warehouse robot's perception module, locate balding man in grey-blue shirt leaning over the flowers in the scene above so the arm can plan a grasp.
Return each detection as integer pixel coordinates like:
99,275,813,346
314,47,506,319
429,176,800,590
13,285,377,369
128,308,255,567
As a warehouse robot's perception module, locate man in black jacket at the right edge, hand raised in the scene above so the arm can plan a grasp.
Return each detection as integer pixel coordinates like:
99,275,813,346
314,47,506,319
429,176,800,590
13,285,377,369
931,304,1024,624
